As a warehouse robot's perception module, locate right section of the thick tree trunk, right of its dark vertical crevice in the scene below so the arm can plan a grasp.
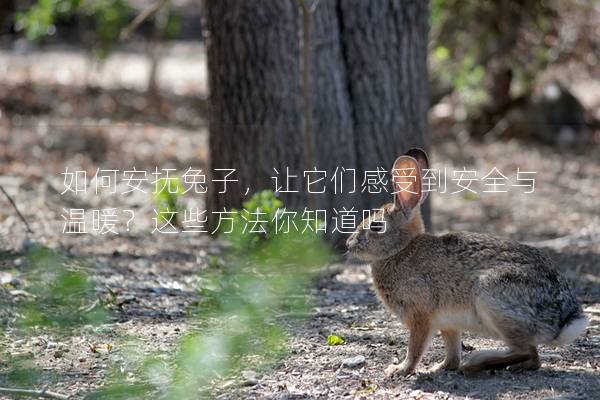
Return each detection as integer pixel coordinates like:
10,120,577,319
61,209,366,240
338,0,430,225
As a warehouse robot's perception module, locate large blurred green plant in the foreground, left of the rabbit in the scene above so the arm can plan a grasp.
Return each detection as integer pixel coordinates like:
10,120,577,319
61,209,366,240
88,191,331,399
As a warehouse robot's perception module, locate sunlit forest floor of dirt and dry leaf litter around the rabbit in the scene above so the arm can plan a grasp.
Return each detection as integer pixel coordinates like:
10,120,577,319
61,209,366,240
0,42,600,400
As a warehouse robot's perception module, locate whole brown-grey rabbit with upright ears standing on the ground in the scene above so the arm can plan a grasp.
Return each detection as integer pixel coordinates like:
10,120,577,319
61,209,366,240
346,149,589,376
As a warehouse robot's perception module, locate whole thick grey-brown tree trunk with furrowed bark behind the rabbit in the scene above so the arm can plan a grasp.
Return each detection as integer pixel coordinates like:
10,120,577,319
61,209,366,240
205,0,429,240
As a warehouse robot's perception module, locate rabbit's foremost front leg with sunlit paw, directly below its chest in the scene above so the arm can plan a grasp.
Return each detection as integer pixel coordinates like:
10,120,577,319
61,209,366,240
385,318,431,377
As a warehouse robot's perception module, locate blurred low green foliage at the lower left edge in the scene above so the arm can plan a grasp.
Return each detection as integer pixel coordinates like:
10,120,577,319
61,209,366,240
0,243,109,394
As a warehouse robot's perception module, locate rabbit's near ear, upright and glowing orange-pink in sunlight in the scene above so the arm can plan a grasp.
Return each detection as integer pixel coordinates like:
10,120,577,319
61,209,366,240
392,156,423,216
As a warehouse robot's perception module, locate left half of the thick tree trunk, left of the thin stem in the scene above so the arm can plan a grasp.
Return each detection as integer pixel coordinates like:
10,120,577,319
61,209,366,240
205,0,304,219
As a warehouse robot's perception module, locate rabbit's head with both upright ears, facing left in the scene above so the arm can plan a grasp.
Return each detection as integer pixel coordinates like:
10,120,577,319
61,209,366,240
346,149,429,262
